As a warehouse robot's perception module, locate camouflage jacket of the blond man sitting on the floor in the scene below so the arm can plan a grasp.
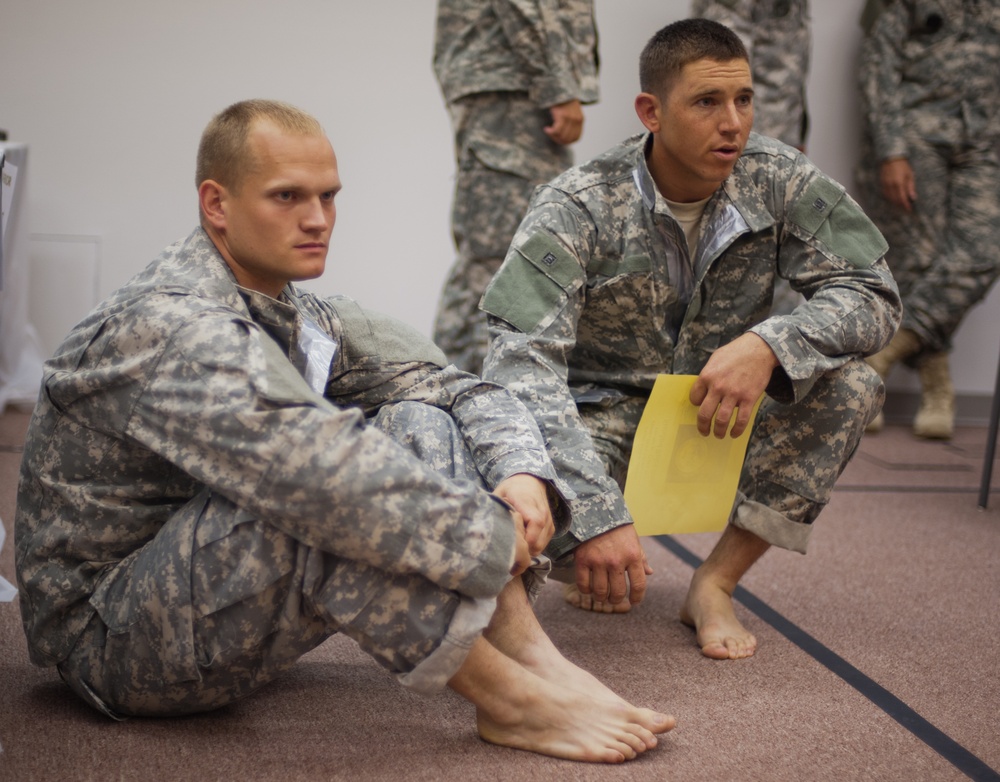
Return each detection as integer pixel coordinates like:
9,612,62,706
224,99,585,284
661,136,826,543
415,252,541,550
15,228,555,665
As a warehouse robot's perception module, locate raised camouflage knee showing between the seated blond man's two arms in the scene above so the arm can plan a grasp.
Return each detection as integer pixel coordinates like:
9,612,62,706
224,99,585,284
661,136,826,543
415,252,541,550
371,401,482,485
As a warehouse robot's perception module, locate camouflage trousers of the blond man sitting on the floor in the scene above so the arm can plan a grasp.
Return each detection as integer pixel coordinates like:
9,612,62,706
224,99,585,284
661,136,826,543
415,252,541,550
59,402,504,718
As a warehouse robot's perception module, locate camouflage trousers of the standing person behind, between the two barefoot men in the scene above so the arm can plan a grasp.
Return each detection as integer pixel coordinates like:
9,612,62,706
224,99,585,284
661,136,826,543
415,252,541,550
434,92,573,375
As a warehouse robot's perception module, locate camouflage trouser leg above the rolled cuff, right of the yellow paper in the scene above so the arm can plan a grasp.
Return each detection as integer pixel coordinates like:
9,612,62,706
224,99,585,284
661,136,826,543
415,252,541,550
740,359,885,524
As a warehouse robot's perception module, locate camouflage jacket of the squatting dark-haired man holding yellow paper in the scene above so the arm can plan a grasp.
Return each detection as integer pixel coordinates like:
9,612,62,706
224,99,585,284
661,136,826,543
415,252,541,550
483,133,901,556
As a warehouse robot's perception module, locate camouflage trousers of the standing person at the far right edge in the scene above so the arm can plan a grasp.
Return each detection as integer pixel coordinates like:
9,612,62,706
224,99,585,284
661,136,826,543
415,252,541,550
859,134,1000,363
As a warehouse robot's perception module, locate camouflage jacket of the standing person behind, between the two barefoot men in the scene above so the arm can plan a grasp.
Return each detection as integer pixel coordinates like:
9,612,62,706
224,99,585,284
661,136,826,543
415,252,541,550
434,0,598,108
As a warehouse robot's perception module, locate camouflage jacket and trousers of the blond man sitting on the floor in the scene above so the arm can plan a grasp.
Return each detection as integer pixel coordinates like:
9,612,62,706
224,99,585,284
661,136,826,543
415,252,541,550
15,228,566,715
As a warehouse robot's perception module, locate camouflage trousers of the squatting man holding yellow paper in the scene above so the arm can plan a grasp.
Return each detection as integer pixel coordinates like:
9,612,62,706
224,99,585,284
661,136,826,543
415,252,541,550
553,359,885,560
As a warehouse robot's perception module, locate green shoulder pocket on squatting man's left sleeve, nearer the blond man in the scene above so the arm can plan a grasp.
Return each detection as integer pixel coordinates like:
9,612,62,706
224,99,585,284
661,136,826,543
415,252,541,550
481,234,583,333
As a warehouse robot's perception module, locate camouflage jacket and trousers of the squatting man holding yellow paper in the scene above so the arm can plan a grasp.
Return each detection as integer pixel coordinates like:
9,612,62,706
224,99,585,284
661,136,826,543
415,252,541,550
483,133,900,558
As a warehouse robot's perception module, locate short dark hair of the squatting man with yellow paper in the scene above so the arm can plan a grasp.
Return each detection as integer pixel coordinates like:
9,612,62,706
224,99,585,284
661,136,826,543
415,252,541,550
639,19,750,98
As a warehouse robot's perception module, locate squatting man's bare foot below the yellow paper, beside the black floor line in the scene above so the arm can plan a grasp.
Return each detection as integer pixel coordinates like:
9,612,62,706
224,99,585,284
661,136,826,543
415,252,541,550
681,572,757,660
